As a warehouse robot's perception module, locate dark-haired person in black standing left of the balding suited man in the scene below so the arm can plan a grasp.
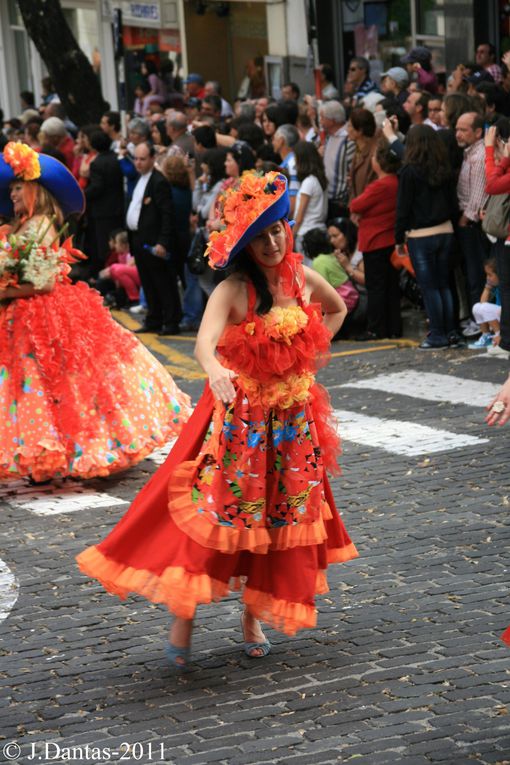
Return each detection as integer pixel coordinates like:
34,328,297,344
85,129,124,278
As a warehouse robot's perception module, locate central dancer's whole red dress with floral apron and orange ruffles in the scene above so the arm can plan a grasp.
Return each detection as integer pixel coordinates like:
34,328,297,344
77,278,357,635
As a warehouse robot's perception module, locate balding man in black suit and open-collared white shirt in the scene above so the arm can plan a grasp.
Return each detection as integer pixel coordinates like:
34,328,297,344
126,142,182,335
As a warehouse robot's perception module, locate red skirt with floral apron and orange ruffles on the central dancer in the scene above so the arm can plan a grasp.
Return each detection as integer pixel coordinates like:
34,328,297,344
77,386,357,635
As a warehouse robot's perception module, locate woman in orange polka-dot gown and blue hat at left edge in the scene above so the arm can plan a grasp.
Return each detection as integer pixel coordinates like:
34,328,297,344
0,143,191,482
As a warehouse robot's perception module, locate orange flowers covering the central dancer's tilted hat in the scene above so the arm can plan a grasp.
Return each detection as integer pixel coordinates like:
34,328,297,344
205,171,285,268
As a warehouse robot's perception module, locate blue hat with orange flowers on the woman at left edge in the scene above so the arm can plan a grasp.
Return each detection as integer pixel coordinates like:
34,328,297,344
0,141,85,217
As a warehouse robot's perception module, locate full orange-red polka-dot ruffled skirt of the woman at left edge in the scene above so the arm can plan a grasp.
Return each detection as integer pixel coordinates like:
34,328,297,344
0,281,191,481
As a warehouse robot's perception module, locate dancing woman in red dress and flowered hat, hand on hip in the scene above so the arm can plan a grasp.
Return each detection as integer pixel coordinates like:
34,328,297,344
78,173,357,668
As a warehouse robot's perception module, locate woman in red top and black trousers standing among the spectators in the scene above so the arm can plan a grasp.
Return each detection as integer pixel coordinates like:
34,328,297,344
349,139,402,340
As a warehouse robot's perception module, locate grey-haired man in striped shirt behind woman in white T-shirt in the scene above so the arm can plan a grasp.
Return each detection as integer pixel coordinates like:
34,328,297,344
319,101,356,218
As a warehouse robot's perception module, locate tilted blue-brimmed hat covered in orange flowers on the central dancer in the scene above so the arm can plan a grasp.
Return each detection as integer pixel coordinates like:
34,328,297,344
205,171,290,269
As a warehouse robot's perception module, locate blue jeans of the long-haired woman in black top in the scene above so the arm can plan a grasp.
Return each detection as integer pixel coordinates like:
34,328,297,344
407,234,455,345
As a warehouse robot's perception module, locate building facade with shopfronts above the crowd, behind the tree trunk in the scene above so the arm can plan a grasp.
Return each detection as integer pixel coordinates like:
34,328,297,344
0,0,510,118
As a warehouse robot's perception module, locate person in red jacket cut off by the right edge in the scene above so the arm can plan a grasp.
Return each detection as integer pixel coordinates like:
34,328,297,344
485,125,510,355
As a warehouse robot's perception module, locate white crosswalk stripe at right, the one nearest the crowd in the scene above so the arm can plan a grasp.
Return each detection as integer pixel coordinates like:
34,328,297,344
333,370,501,406
